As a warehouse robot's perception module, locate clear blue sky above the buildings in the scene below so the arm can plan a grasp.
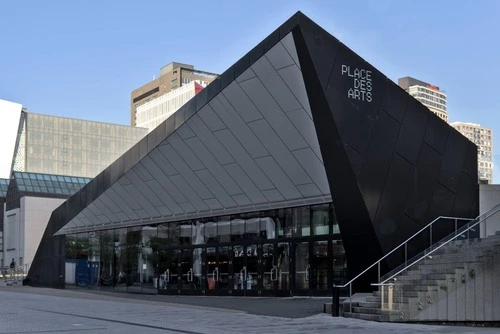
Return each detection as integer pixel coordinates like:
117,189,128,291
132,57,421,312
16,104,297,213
0,0,500,179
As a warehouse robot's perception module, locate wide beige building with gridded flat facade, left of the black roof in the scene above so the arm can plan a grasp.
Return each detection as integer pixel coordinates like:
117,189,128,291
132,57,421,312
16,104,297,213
11,110,147,178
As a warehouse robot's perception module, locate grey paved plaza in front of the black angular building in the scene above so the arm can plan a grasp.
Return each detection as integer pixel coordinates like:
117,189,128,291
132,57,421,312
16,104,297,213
0,286,500,334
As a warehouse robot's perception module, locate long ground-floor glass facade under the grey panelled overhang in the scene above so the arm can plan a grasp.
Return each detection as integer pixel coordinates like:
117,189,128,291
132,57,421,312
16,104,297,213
66,203,346,296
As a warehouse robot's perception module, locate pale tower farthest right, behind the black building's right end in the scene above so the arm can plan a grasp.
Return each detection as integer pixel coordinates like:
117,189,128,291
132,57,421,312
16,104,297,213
450,122,493,183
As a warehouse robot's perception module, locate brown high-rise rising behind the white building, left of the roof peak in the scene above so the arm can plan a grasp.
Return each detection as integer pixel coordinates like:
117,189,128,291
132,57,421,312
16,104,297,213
130,62,218,126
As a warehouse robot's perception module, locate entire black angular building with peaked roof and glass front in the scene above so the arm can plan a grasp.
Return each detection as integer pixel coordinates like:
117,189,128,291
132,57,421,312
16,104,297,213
28,12,478,295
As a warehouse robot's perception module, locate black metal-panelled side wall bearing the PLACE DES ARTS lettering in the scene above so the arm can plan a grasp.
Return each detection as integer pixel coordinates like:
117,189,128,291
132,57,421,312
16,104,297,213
294,12,478,275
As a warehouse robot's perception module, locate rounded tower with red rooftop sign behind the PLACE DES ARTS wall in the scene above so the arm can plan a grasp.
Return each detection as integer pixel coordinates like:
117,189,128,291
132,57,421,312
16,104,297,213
398,77,448,122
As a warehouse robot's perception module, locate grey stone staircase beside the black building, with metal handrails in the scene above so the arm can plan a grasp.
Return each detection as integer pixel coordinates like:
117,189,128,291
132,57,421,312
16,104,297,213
341,232,500,322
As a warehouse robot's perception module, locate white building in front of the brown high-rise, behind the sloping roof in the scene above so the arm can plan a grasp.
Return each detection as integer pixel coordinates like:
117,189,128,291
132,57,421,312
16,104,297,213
136,81,206,132
